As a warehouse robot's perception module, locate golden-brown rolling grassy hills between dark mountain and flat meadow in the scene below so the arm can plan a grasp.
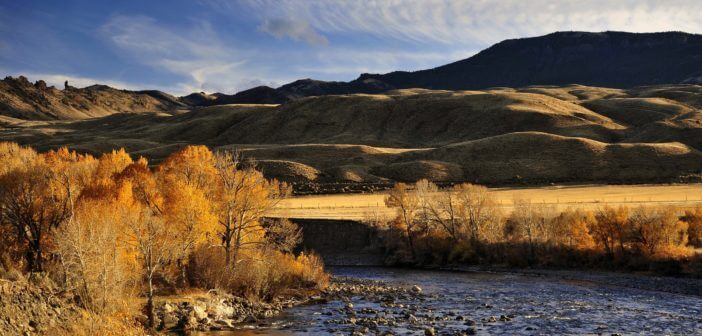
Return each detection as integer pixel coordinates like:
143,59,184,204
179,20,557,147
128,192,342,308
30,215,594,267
0,85,702,185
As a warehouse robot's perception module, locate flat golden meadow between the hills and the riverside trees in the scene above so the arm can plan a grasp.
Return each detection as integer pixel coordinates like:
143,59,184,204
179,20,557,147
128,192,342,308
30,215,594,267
271,184,702,220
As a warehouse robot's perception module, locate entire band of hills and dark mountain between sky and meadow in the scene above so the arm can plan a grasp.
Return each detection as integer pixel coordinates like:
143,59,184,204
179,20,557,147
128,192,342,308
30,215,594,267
0,32,702,184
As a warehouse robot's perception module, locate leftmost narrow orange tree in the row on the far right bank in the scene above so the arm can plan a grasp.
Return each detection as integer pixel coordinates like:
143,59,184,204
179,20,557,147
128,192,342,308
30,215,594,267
385,183,420,260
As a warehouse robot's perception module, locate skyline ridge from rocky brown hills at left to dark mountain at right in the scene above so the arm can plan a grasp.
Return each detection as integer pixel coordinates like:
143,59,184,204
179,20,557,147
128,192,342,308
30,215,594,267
5,31,702,120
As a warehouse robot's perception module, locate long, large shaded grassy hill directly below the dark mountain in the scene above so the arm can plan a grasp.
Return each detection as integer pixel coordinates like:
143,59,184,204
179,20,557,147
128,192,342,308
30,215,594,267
215,90,624,147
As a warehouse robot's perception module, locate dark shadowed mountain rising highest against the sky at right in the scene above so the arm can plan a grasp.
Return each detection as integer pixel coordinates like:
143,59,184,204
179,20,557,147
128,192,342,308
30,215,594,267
219,31,702,105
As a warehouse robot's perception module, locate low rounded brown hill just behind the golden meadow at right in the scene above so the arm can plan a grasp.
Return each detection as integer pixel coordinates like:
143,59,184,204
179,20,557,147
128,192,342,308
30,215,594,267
408,132,702,183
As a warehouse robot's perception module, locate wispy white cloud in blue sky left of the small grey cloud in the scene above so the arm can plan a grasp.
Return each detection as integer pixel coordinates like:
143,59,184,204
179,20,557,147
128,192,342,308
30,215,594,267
102,16,286,94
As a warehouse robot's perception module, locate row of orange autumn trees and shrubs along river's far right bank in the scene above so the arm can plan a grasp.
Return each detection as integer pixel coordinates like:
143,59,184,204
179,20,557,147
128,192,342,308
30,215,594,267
374,180,702,276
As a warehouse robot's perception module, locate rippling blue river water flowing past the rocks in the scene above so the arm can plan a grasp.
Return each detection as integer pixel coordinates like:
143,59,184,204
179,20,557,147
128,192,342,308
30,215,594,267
199,267,702,336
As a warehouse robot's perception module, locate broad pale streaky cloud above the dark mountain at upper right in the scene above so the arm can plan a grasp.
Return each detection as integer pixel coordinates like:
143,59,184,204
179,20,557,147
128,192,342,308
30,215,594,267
235,0,702,45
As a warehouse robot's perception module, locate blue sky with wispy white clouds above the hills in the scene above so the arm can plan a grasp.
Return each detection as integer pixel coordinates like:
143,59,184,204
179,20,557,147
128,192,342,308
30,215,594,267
0,0,702,95
